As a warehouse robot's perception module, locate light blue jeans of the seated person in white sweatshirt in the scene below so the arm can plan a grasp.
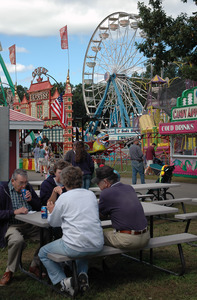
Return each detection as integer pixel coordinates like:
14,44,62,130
38,239,101,285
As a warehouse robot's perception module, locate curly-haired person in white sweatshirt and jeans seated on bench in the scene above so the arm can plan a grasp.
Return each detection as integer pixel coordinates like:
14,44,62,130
38,166,103,296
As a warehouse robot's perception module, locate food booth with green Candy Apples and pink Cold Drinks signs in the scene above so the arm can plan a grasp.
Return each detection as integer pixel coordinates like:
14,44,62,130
159,87,197,178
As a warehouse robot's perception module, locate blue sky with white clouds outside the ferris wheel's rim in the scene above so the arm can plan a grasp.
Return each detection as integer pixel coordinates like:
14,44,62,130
0,0,196,87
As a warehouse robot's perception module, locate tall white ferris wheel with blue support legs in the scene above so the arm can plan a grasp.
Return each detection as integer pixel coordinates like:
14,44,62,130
82,12,147,134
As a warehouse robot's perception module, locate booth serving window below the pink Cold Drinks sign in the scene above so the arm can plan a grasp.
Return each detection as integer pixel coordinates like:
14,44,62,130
173,135,197,155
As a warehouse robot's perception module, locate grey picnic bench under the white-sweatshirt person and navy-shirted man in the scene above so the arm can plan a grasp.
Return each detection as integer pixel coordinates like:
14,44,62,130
47,233,197,295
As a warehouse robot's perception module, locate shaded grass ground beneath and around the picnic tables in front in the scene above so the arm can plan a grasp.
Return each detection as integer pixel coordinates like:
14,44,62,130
0,205,197,300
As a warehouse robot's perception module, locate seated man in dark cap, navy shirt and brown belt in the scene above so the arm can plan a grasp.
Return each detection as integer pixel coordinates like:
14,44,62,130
92,166,150,250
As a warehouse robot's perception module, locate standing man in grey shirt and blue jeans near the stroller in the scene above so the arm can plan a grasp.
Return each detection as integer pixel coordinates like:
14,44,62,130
129,137,145,184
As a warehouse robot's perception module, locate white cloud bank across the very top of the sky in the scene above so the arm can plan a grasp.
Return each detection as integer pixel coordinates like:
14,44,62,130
0,0,195,37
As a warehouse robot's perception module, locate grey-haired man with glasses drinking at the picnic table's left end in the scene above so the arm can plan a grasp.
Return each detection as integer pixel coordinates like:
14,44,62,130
0,169,41,286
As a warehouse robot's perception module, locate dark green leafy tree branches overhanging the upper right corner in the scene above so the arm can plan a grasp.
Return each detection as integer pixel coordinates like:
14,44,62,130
136,0,197,80
